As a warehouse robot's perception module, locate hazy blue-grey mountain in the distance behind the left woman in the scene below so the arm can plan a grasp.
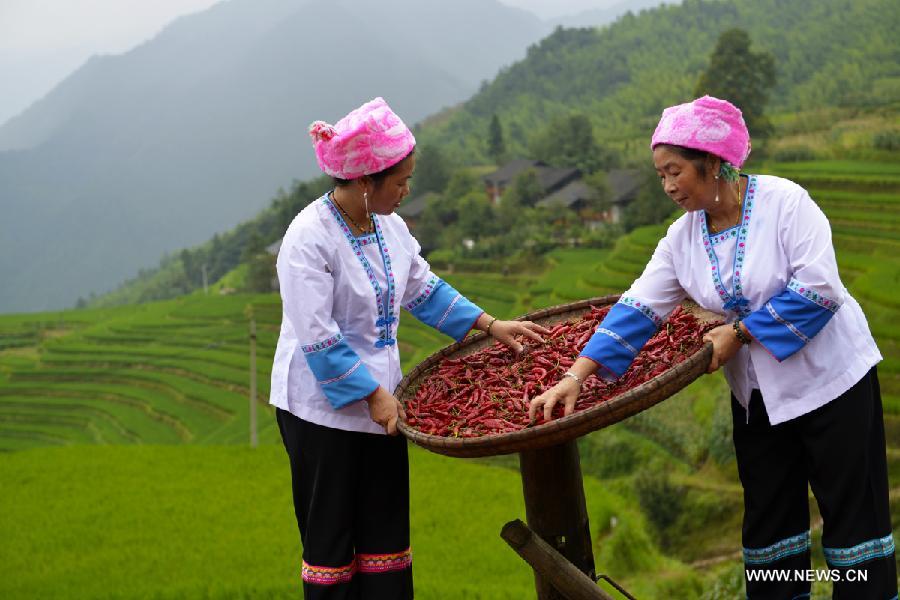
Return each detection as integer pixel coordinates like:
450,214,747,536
0,0,546,312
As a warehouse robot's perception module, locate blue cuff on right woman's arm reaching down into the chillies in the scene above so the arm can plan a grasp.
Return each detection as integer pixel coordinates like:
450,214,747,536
581,302,658,379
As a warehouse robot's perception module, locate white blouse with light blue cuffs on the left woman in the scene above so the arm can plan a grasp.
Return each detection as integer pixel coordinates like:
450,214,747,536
269,194,483,433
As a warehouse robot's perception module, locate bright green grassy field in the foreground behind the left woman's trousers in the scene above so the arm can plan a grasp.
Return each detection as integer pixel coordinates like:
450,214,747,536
0,445,692,600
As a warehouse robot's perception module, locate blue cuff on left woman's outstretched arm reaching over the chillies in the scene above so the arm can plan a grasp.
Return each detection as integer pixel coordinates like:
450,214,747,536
405,277,484,341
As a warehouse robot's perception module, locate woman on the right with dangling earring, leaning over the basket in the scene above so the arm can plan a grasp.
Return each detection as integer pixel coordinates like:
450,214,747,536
531,96,897,600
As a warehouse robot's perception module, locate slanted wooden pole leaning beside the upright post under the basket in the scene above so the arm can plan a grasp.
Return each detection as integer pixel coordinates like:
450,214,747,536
500,519,613,600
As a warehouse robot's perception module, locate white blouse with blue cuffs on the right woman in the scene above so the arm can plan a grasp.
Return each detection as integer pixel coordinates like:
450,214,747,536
582,175,882,425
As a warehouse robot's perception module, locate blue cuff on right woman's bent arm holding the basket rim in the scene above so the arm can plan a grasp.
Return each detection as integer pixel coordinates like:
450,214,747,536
744,282,840,362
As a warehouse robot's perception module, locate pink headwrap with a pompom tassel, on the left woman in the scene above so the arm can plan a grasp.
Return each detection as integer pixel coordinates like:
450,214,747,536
309,98,416,179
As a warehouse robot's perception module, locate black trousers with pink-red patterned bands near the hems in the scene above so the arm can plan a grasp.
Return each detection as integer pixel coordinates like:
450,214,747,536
276,409,413,600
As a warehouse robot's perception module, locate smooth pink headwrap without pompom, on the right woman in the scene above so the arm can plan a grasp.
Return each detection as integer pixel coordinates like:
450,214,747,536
650,96,750,169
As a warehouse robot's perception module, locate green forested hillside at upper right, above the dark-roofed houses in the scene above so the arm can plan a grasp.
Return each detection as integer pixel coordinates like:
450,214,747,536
420,0,900,164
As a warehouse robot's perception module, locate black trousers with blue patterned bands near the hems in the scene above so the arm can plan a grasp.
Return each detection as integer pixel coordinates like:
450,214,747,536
731,368,897,600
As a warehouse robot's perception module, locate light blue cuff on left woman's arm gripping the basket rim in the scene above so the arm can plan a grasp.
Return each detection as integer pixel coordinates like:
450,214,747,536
302,334,378,409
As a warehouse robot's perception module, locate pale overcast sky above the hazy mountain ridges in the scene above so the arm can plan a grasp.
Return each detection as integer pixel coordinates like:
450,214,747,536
0,0,620,125
